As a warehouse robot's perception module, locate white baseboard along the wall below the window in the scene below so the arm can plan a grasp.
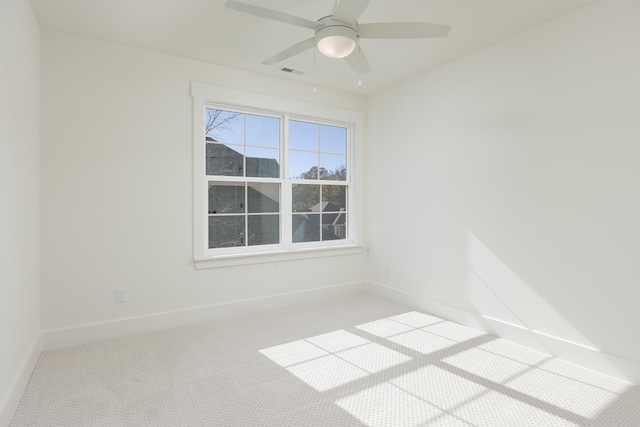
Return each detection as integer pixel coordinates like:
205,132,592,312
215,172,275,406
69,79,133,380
42,283,367,350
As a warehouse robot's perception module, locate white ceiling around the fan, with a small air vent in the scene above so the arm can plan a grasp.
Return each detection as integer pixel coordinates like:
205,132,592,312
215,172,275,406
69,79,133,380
31,0,597,94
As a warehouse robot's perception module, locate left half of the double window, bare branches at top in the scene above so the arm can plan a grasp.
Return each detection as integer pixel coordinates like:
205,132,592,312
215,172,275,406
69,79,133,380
203,111,281,249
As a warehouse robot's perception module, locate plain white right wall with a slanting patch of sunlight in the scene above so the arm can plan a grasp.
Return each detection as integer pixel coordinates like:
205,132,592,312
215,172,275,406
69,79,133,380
367,0,640,380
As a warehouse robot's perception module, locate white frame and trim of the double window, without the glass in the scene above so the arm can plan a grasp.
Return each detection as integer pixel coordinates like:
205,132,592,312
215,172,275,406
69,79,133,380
191,82,364,269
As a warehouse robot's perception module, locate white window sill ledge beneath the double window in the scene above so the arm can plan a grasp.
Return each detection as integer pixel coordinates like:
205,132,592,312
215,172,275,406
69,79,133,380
194,245,365,270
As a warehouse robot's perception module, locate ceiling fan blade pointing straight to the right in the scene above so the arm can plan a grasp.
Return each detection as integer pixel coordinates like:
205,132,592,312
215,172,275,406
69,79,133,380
358,22,451,39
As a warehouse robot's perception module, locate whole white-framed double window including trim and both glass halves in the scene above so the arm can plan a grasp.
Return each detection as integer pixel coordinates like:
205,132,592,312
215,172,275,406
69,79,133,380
192,83,362,268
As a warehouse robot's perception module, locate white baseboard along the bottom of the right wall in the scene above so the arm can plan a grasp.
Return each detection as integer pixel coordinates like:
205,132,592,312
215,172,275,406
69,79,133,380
367,282,640,385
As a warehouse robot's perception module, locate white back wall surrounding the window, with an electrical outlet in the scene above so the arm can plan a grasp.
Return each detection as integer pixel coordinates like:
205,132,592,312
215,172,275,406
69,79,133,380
41,31,366,342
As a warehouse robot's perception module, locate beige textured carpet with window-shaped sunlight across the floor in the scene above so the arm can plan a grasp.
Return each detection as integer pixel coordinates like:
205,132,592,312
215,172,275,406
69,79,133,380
11,294,640,427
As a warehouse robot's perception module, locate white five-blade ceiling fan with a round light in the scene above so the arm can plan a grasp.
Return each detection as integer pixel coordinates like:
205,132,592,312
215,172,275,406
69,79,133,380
226,0,451,75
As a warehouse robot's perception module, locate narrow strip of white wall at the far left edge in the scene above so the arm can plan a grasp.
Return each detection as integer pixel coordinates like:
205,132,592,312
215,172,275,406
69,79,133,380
0,0,40,425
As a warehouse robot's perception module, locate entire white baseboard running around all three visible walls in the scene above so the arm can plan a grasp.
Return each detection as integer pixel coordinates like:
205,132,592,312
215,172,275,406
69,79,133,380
38,282,640,384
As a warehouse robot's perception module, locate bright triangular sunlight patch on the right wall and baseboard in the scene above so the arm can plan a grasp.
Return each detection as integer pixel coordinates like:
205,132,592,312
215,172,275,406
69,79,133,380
465,230,639,382
